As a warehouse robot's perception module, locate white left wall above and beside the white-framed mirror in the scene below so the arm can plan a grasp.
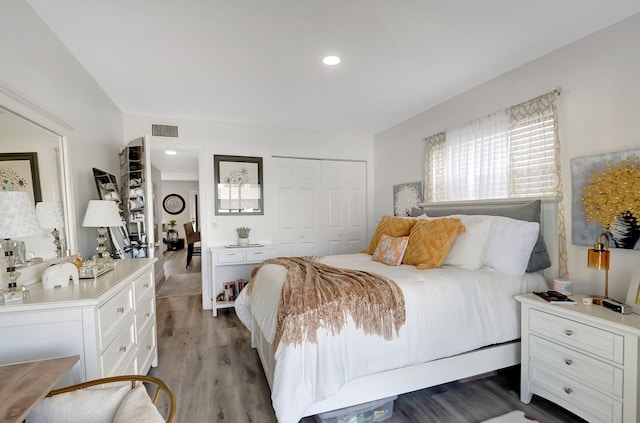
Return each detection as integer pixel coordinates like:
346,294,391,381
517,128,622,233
0,0,123,256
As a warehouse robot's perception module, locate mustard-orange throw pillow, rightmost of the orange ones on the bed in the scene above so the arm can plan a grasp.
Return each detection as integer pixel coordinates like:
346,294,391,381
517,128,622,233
402,218,466,269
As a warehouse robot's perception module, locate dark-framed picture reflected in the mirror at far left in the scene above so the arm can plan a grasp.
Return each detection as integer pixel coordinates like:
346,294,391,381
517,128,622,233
0,153,42,206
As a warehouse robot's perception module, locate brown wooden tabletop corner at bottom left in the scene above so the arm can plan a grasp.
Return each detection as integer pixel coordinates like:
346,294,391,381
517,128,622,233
0,355,80,423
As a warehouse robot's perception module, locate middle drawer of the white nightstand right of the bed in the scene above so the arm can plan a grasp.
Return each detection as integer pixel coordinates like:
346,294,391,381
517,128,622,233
529,335,623,397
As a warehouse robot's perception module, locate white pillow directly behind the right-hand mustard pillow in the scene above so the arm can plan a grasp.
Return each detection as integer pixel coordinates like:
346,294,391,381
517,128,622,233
444,215,493,270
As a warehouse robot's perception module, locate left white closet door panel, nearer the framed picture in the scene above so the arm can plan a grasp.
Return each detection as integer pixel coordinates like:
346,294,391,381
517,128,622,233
273,158,326,257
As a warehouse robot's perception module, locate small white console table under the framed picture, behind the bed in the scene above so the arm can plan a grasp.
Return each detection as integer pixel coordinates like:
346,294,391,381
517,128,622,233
209,245,276,316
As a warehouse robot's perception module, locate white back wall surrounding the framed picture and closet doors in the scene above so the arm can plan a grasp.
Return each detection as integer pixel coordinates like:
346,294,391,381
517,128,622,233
125,115,373,308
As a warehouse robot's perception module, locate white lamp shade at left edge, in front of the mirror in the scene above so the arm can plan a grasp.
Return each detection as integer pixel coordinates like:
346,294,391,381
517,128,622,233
0,191,42,238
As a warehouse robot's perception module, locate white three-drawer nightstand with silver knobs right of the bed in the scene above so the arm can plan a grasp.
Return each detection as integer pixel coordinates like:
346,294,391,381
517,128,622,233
516,294,640,423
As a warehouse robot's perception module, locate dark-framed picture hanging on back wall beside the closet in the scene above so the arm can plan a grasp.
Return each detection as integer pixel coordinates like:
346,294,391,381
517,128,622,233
213,155,264,216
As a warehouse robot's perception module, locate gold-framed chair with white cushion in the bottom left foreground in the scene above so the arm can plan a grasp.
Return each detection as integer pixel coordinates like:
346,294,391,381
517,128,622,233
25,375,176,423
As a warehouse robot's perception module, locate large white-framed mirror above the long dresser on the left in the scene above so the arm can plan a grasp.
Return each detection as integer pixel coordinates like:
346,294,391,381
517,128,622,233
0,94,76,274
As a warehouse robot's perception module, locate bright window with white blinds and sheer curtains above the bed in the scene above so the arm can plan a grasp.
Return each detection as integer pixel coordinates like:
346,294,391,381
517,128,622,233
425,92,561,202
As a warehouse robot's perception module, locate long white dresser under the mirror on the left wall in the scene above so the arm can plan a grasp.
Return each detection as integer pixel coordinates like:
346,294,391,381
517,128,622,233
0,258,158,386
